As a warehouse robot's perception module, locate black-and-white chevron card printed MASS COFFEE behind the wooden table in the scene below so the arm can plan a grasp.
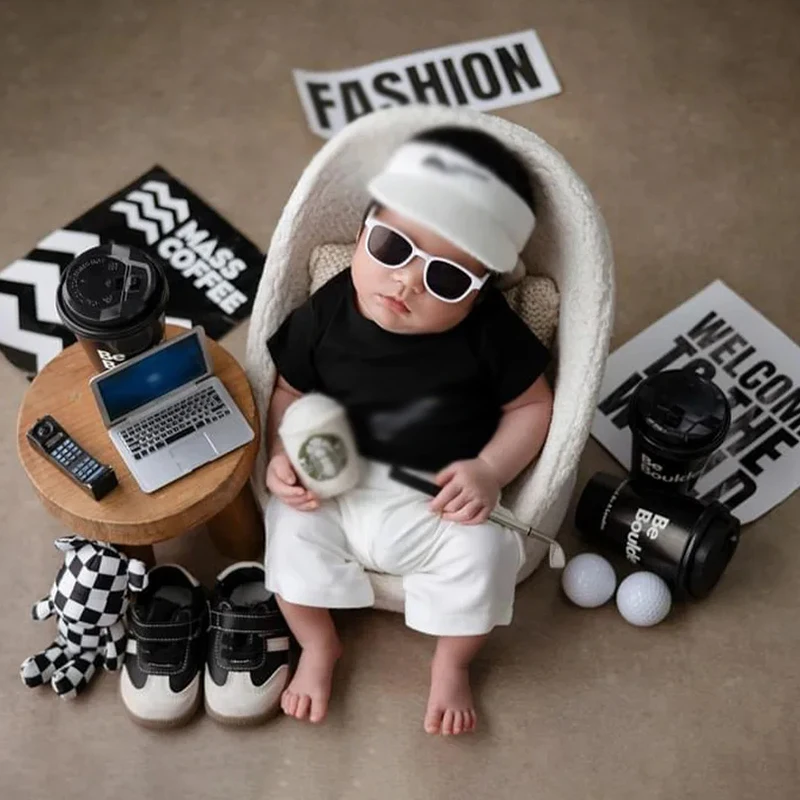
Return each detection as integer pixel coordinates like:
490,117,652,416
0,166,264,376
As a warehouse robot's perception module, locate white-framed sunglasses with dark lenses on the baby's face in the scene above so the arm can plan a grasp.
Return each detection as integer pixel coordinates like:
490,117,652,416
364,214,489,303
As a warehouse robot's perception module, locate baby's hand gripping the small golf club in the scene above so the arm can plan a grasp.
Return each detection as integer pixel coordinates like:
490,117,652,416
430,458,500,525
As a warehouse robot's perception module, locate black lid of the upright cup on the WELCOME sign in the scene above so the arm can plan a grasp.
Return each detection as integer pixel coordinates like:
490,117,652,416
630,369,731,454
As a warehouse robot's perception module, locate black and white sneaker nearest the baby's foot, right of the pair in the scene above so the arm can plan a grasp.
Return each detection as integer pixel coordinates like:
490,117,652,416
205,561,290,725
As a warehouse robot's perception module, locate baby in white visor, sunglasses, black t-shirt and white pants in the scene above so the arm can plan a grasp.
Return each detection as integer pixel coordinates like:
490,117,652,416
266,127,552,735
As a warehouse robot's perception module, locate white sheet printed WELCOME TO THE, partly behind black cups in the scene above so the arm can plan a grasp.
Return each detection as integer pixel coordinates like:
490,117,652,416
592,281,800,522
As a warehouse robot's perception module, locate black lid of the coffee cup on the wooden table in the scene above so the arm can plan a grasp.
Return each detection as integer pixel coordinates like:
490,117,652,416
57,244,168,336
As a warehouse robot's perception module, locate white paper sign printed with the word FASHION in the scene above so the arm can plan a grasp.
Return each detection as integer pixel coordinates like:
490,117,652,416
294,30,561,139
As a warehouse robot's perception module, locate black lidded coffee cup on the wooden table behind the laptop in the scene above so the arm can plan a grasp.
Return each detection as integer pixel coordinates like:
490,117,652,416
56,244,169,370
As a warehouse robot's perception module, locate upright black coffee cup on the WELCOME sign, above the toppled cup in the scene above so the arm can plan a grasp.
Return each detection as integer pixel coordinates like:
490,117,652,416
629,370,731,493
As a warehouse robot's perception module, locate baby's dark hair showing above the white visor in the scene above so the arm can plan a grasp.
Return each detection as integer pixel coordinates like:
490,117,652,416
412,125,536,213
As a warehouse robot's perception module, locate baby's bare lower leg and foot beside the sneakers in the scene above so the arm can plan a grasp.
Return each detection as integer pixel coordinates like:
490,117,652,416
278,596,342,722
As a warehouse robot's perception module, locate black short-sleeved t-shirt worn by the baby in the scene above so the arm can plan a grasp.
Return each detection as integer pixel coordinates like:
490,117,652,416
268,269,550,471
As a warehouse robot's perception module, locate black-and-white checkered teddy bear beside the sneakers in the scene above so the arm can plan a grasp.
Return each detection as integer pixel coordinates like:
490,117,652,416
20,536,147,698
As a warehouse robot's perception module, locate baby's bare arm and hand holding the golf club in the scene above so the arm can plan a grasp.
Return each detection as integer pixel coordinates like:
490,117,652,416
430,375,553,525
